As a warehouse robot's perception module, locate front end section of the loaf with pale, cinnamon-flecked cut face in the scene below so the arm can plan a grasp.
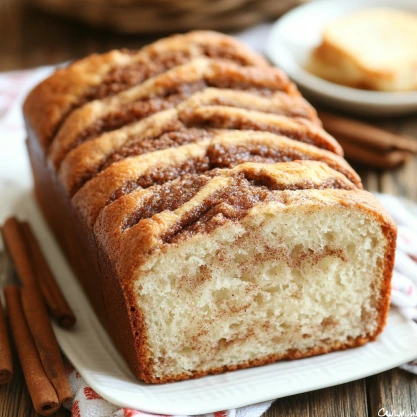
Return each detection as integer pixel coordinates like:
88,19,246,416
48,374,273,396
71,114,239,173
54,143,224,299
94,162,396,383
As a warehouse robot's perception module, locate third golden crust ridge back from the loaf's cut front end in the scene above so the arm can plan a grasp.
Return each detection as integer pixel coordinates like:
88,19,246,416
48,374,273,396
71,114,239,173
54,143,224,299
59,101,342,196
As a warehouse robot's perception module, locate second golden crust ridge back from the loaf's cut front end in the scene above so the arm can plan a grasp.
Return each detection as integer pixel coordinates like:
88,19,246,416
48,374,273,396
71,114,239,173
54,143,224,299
72,131,362,225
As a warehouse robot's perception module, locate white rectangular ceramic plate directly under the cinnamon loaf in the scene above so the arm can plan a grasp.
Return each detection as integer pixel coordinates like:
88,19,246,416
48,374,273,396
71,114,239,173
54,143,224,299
15,194,417,415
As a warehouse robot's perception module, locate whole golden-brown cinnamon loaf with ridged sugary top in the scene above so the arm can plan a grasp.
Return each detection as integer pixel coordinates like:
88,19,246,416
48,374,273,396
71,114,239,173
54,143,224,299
24,31,396,383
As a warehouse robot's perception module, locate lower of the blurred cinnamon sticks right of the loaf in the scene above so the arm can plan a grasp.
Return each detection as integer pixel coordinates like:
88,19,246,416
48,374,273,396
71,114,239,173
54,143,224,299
338,137,411,169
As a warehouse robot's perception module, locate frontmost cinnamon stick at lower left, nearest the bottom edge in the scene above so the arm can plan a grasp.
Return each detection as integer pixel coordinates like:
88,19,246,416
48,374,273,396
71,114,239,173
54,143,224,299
4,285,60,416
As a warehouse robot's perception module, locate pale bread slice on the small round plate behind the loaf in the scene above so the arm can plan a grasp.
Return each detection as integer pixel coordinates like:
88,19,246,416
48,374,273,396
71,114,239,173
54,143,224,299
308,9,417,91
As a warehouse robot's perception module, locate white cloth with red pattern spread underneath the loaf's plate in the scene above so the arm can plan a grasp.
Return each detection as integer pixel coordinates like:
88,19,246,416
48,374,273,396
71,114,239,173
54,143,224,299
0,57,417,417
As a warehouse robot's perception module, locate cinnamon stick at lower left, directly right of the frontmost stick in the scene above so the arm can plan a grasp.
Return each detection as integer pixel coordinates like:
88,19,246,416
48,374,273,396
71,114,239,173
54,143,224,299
21,285,72,403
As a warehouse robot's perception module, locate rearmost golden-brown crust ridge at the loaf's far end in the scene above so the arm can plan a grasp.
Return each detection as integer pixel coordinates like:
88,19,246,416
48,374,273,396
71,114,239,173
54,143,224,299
24,31,268,149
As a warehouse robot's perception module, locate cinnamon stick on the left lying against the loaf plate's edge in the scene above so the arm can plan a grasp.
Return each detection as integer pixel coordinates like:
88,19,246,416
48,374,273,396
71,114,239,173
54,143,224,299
21,222,76,327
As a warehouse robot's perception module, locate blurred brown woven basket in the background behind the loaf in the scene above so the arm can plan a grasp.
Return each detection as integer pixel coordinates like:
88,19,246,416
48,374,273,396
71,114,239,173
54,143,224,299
0,0,303,71
